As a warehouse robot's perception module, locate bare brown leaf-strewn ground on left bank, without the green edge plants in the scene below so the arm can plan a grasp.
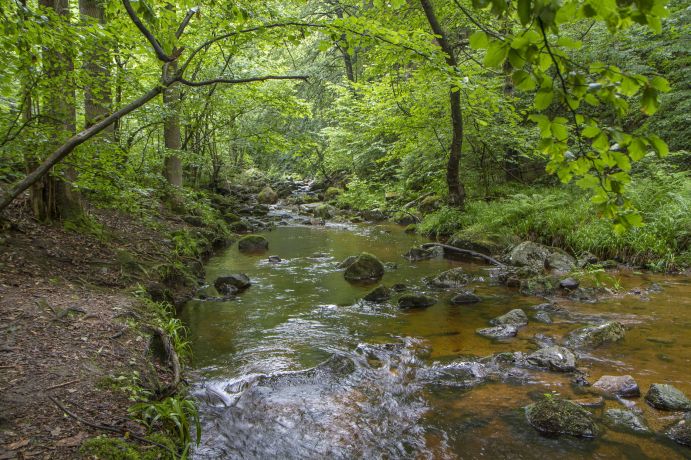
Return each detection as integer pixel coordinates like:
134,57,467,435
0,197,201,460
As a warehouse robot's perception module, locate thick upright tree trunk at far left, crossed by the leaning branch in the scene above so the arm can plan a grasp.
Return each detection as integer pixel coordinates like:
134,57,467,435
36,0,82,220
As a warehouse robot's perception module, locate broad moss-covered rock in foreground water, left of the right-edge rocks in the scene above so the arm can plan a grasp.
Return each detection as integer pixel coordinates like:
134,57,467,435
525,397,599,438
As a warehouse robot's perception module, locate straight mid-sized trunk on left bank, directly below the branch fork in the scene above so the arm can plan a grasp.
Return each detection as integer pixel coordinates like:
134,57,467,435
163,62,182,187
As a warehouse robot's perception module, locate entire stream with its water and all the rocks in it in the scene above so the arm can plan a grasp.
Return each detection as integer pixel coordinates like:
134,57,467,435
181,195,691,458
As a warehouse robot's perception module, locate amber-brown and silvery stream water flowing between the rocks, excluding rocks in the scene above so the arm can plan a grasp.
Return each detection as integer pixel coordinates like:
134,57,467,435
181,217,691,459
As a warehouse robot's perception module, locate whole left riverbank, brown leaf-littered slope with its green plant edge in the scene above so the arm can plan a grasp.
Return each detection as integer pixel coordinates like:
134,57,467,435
0,192,238,459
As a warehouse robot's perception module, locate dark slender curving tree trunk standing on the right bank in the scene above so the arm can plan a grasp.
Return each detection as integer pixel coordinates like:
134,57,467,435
420,0,465,209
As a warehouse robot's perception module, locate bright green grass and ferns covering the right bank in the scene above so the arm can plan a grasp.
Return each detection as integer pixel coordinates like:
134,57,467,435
418,173,691,271
